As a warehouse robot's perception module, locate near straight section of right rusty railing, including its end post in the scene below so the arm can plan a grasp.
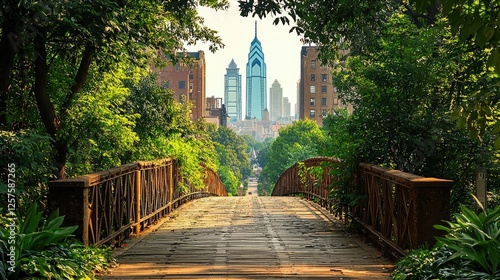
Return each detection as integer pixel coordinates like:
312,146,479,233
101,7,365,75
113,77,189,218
354,163,453,257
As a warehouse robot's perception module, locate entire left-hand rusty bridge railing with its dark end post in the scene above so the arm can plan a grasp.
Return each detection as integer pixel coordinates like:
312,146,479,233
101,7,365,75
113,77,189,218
48,159,227,246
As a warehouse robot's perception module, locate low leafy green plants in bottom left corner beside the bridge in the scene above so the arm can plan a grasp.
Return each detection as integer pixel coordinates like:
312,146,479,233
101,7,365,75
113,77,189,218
0,203,114,279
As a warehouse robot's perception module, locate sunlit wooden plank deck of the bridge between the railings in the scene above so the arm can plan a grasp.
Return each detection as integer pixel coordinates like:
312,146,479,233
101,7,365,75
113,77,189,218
101,196,392,279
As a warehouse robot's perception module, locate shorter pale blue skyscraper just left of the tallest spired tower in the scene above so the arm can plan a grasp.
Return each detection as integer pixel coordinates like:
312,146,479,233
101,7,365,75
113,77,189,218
224,59,242,123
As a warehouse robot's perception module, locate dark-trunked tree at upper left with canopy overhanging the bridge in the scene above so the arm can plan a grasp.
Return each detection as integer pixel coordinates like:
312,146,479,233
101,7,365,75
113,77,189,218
0,0,227,178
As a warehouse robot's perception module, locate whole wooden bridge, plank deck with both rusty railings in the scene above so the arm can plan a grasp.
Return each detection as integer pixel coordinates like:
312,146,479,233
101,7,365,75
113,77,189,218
49,157,452,279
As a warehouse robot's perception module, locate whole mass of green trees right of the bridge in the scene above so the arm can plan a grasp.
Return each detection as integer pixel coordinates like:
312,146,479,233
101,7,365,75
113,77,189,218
247,0,500,211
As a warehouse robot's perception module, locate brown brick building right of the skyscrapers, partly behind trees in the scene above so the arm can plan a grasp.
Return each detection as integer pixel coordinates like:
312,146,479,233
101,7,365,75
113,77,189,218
298,46,346,125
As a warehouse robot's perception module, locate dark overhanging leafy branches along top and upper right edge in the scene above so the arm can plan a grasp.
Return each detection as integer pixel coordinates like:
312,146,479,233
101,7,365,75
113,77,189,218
239,0,500,149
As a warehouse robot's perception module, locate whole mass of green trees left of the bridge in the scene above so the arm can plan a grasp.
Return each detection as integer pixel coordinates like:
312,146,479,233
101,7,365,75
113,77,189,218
0,0,258,213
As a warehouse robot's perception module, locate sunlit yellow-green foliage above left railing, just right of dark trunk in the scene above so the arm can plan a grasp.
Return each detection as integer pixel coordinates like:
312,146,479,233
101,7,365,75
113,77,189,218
60,68,141,176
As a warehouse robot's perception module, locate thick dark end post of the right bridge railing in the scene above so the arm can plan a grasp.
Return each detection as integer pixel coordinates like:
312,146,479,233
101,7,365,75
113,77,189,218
411,178,453,248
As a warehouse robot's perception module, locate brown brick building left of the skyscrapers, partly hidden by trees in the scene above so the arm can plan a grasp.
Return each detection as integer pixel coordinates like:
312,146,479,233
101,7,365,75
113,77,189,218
156,51,206,122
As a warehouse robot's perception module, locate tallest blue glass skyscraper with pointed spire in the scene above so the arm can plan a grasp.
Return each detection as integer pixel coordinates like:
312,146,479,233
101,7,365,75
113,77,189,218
246,22,267,120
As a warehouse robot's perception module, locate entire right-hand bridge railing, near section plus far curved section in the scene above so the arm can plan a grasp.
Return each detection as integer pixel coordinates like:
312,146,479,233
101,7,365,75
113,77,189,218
273,158,453,258
